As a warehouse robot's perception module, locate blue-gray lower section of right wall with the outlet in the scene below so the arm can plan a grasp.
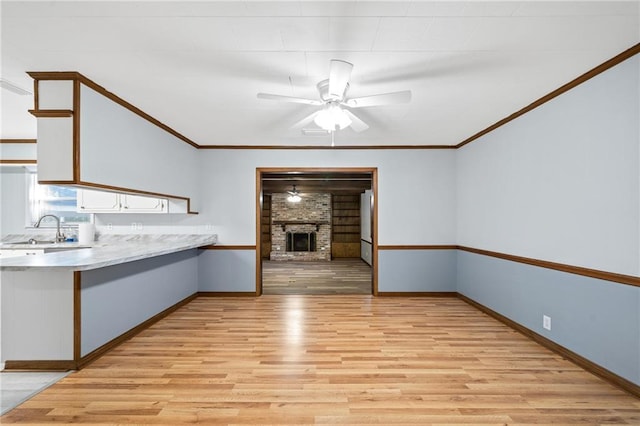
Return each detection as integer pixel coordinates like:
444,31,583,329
457,251,640,384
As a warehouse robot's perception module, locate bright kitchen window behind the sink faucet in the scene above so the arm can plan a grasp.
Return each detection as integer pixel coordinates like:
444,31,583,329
27,173,91,227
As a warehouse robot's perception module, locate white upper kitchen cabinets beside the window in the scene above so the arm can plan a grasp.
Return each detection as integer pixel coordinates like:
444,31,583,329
77,189,168,213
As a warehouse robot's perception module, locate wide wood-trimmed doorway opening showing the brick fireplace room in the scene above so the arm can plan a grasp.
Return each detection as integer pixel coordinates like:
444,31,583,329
256,168,377,295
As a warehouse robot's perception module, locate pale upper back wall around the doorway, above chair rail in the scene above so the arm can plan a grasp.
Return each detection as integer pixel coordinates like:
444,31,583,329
194,149,456,245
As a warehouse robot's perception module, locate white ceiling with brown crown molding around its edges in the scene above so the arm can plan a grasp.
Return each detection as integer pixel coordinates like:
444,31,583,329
0,0,640,146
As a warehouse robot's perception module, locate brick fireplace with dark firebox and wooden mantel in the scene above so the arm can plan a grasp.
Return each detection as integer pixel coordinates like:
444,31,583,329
270,194,331,260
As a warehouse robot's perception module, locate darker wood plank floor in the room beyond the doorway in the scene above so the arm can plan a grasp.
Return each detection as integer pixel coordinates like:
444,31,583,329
262,259,373,294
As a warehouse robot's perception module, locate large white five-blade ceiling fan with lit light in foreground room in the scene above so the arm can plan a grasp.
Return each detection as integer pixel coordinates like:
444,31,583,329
258,59,411,133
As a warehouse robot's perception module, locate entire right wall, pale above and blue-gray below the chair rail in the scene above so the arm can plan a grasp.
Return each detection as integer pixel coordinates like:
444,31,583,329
457,56,640,385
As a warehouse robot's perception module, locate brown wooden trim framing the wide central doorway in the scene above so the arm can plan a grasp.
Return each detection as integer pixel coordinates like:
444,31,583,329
256,167,378,296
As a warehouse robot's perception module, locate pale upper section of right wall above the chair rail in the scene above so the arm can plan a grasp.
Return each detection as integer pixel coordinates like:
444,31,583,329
456,55,640,276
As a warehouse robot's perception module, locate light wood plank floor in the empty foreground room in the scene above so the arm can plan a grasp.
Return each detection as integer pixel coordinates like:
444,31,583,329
0,295,640,425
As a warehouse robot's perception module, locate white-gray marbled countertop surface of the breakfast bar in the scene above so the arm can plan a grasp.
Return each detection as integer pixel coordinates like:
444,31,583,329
0,234,218,271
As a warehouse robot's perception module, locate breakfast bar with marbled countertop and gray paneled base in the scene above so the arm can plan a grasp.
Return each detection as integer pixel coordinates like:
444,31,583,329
0,234,217,370
